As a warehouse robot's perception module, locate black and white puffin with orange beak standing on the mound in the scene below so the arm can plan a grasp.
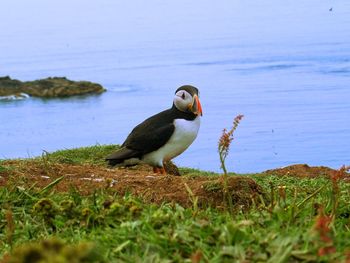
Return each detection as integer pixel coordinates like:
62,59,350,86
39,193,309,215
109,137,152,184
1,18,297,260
106,85,203,174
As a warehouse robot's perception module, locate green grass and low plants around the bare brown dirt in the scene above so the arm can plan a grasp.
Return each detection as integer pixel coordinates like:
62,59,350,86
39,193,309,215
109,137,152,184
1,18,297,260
0,145,350,262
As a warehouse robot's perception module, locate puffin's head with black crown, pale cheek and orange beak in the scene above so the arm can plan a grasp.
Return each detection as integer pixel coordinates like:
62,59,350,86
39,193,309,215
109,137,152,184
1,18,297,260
174,85,203,116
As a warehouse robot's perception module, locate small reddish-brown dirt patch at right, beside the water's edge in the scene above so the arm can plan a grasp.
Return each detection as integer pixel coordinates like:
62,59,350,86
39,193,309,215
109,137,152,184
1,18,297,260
263,164,350,181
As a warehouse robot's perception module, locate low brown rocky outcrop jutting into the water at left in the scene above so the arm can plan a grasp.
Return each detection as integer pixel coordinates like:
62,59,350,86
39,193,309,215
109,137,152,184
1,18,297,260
0,76,105,98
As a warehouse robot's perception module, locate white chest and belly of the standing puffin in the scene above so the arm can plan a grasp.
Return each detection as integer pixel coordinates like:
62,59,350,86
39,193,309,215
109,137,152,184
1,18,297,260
143,116,200,166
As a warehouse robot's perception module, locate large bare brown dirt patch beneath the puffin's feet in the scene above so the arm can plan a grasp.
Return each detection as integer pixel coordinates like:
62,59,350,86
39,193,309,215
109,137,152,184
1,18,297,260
0,161,265,208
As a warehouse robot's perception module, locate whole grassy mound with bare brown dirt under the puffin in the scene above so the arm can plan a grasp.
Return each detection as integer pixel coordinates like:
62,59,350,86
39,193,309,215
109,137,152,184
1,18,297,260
0,146,350,262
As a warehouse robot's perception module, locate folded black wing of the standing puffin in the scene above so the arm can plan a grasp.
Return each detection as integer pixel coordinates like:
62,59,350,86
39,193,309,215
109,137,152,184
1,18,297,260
122,110,175,154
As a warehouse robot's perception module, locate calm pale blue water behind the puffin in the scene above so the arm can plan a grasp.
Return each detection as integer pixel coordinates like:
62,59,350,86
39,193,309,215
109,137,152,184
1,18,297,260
0,0,350,173
